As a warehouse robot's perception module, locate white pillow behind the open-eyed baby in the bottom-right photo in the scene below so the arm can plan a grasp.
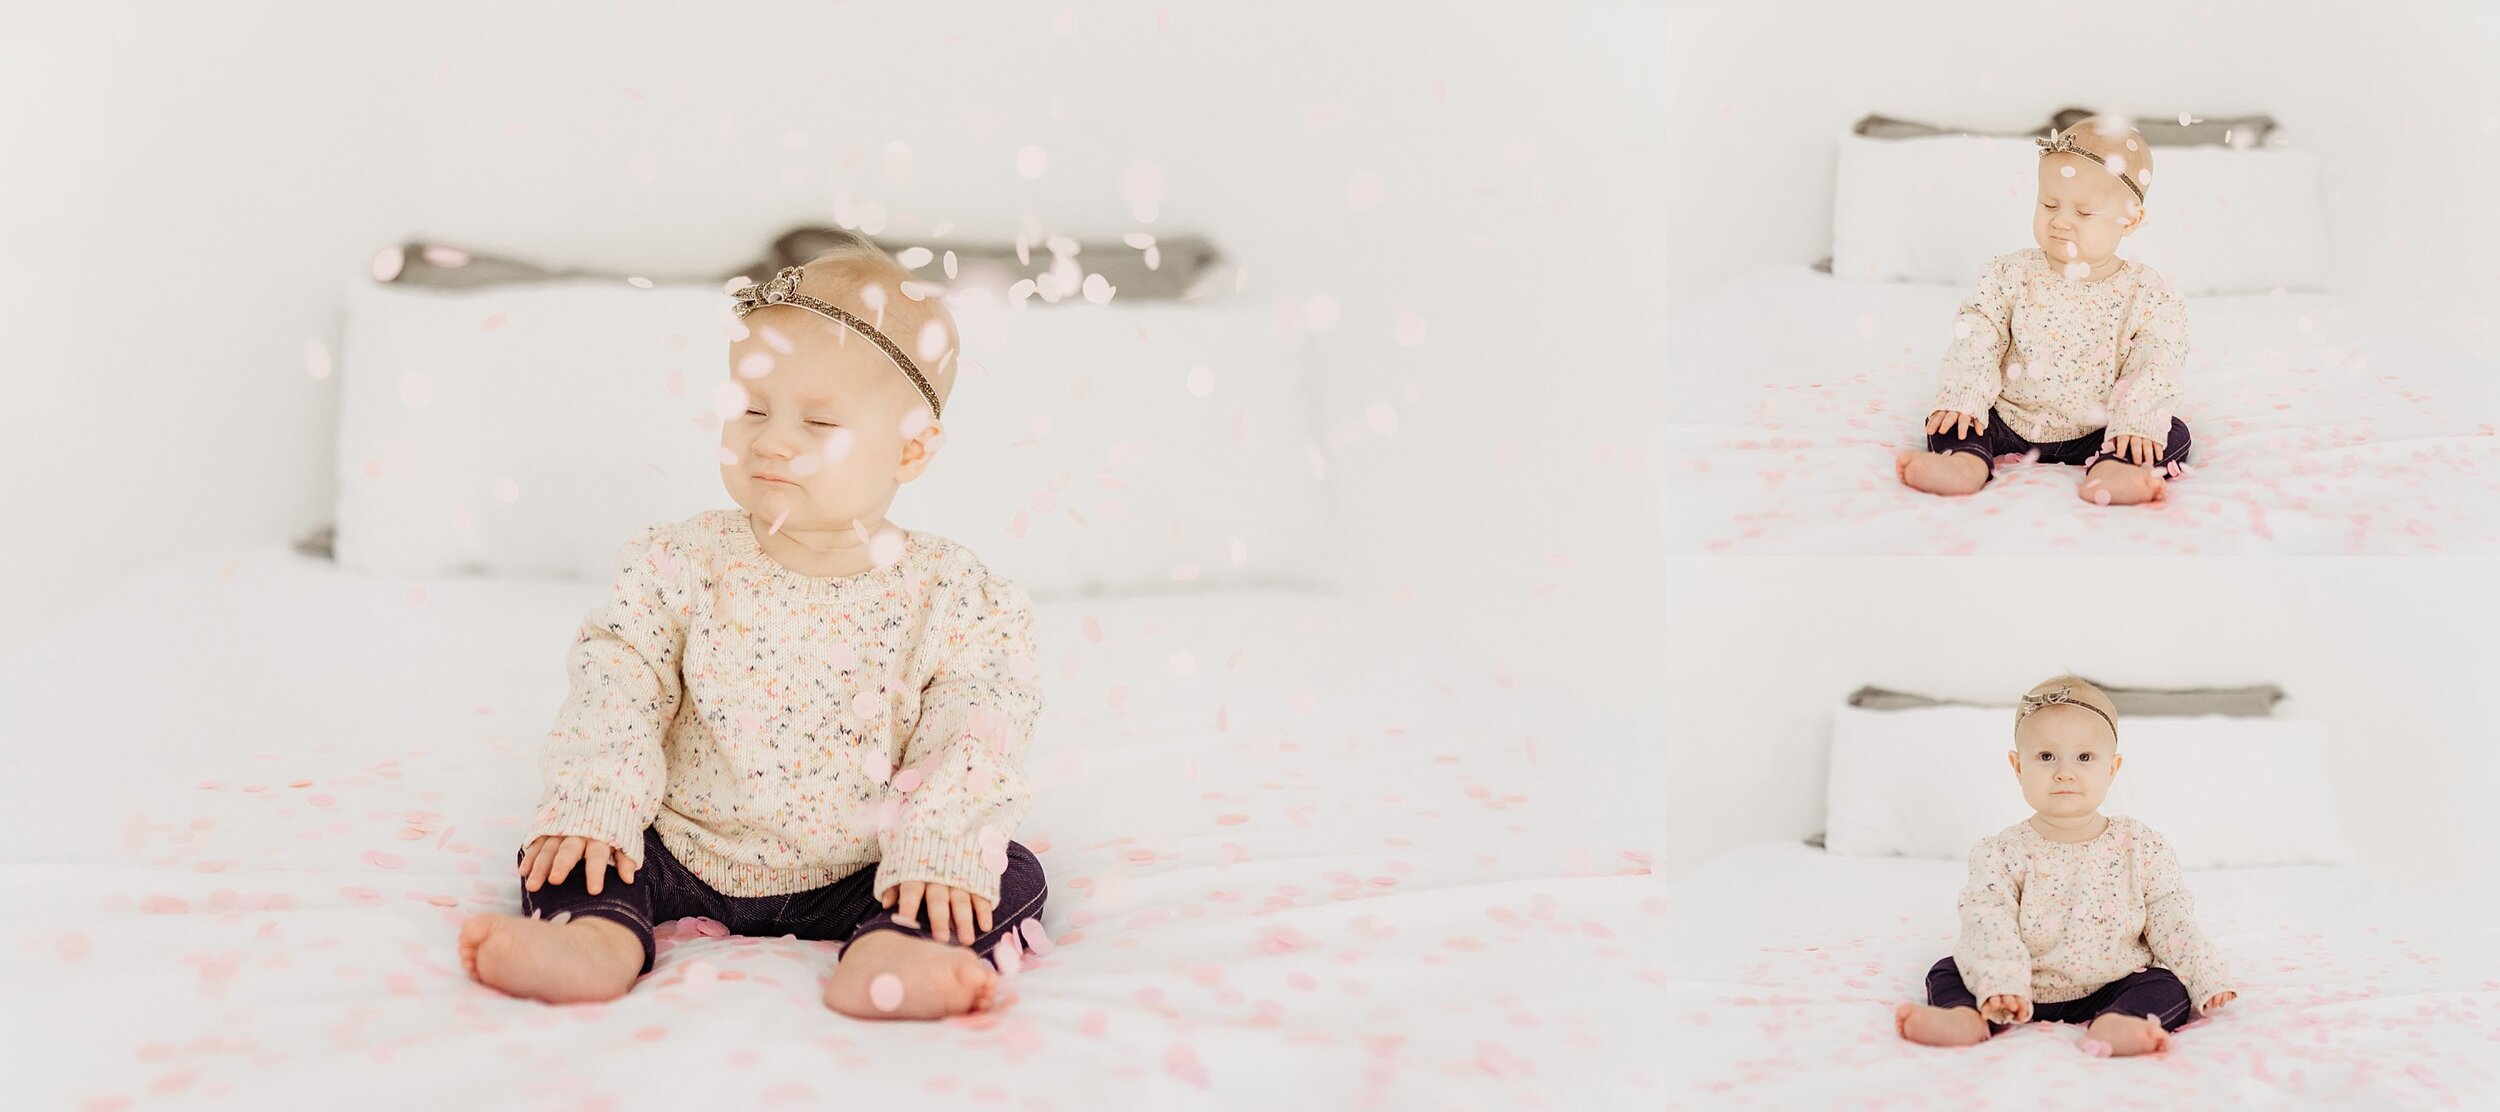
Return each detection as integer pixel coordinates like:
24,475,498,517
1825,707,2353,870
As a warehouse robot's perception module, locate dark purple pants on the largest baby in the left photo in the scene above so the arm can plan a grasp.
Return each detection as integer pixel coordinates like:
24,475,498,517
513,827,1050,972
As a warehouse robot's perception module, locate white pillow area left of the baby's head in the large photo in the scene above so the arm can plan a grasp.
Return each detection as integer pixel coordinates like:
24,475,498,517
333,280,735,582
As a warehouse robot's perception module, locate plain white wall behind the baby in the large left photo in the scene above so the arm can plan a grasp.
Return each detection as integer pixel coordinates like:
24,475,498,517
0,0,1668,729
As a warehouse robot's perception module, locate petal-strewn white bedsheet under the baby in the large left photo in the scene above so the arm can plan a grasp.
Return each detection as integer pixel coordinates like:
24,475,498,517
0,545,1665,1110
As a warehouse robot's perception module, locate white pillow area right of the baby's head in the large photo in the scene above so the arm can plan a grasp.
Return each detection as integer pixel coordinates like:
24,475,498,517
893,297,1335,600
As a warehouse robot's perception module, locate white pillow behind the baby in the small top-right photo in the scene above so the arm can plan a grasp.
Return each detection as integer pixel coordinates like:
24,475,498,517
1833,132,2328,295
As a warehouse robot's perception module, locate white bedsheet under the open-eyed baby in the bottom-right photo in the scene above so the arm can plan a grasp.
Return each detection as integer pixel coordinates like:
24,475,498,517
1660,842,2500,1110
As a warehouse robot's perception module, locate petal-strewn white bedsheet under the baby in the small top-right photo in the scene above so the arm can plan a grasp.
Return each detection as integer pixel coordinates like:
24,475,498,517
1658,265,2500,555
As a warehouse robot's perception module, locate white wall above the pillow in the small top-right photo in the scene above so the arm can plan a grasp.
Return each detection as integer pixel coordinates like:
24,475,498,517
1663,0,2500,313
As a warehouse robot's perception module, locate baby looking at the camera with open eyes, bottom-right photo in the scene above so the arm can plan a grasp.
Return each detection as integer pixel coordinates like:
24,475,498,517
1893,675,2238,1057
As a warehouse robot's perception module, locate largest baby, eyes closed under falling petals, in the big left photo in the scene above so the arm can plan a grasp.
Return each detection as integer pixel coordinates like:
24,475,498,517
460,240,1048,1020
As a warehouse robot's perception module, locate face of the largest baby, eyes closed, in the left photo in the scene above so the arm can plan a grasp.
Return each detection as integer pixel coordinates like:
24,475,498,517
720,305,935,532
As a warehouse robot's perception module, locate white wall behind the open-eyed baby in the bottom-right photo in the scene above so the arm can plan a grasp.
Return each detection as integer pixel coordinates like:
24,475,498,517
1660,557,2500,877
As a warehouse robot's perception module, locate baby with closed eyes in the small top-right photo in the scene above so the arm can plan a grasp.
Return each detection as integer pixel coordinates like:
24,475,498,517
1895,115,2188,505
